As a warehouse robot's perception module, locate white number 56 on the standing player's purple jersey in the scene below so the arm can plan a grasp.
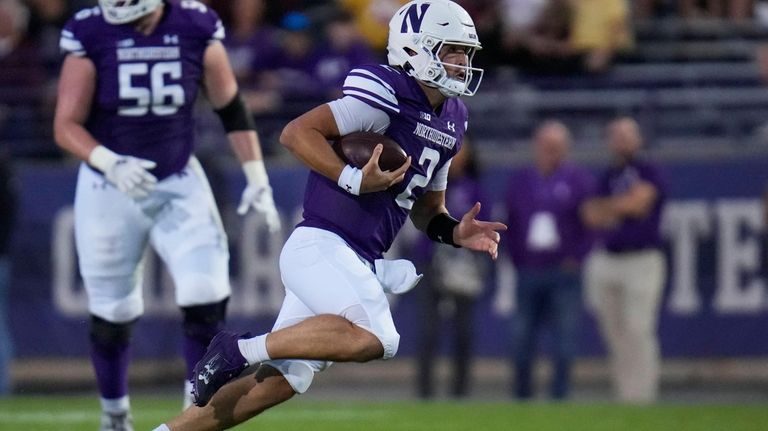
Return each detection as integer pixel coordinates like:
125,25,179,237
118,61,184,117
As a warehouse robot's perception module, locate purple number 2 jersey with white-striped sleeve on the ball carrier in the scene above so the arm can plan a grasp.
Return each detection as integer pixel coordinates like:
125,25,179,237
299,65,467,261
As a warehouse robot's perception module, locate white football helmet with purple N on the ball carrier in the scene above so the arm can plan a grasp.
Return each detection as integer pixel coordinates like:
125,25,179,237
387,0,483,97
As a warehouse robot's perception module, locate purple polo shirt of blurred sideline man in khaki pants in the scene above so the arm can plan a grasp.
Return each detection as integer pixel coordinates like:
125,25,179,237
598,160,666,251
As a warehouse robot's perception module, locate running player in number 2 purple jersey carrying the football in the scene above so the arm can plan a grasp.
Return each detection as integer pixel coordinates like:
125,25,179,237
156,0,506,431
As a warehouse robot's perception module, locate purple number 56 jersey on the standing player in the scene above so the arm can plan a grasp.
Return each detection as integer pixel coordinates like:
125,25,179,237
60,0,224,179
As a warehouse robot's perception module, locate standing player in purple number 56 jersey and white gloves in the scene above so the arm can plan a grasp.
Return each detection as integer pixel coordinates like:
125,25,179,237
54,0,280,430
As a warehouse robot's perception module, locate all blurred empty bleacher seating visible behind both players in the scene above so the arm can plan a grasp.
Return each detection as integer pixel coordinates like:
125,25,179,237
0,19,768,163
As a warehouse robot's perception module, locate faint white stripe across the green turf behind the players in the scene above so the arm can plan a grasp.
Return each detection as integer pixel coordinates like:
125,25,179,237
0,409,389,424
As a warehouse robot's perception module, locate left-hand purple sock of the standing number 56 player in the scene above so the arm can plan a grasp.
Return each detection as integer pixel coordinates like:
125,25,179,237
91,340,131,399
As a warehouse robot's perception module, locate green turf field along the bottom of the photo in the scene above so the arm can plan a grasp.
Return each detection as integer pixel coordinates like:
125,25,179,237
0,396,768,431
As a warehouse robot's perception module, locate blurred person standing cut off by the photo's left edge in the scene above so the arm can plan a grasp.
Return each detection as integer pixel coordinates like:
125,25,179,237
0,151,16,397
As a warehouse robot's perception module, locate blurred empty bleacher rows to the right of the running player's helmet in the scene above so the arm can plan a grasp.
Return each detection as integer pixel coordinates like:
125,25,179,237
468,19,768,163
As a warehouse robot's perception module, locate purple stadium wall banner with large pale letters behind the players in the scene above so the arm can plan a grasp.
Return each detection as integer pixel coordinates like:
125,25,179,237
8,160,768,358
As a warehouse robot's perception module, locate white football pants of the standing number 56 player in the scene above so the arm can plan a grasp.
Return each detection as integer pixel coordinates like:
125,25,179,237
75,157,230,323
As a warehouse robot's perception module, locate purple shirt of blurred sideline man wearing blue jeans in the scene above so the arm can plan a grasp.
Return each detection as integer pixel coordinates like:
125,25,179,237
506,163,595,268
